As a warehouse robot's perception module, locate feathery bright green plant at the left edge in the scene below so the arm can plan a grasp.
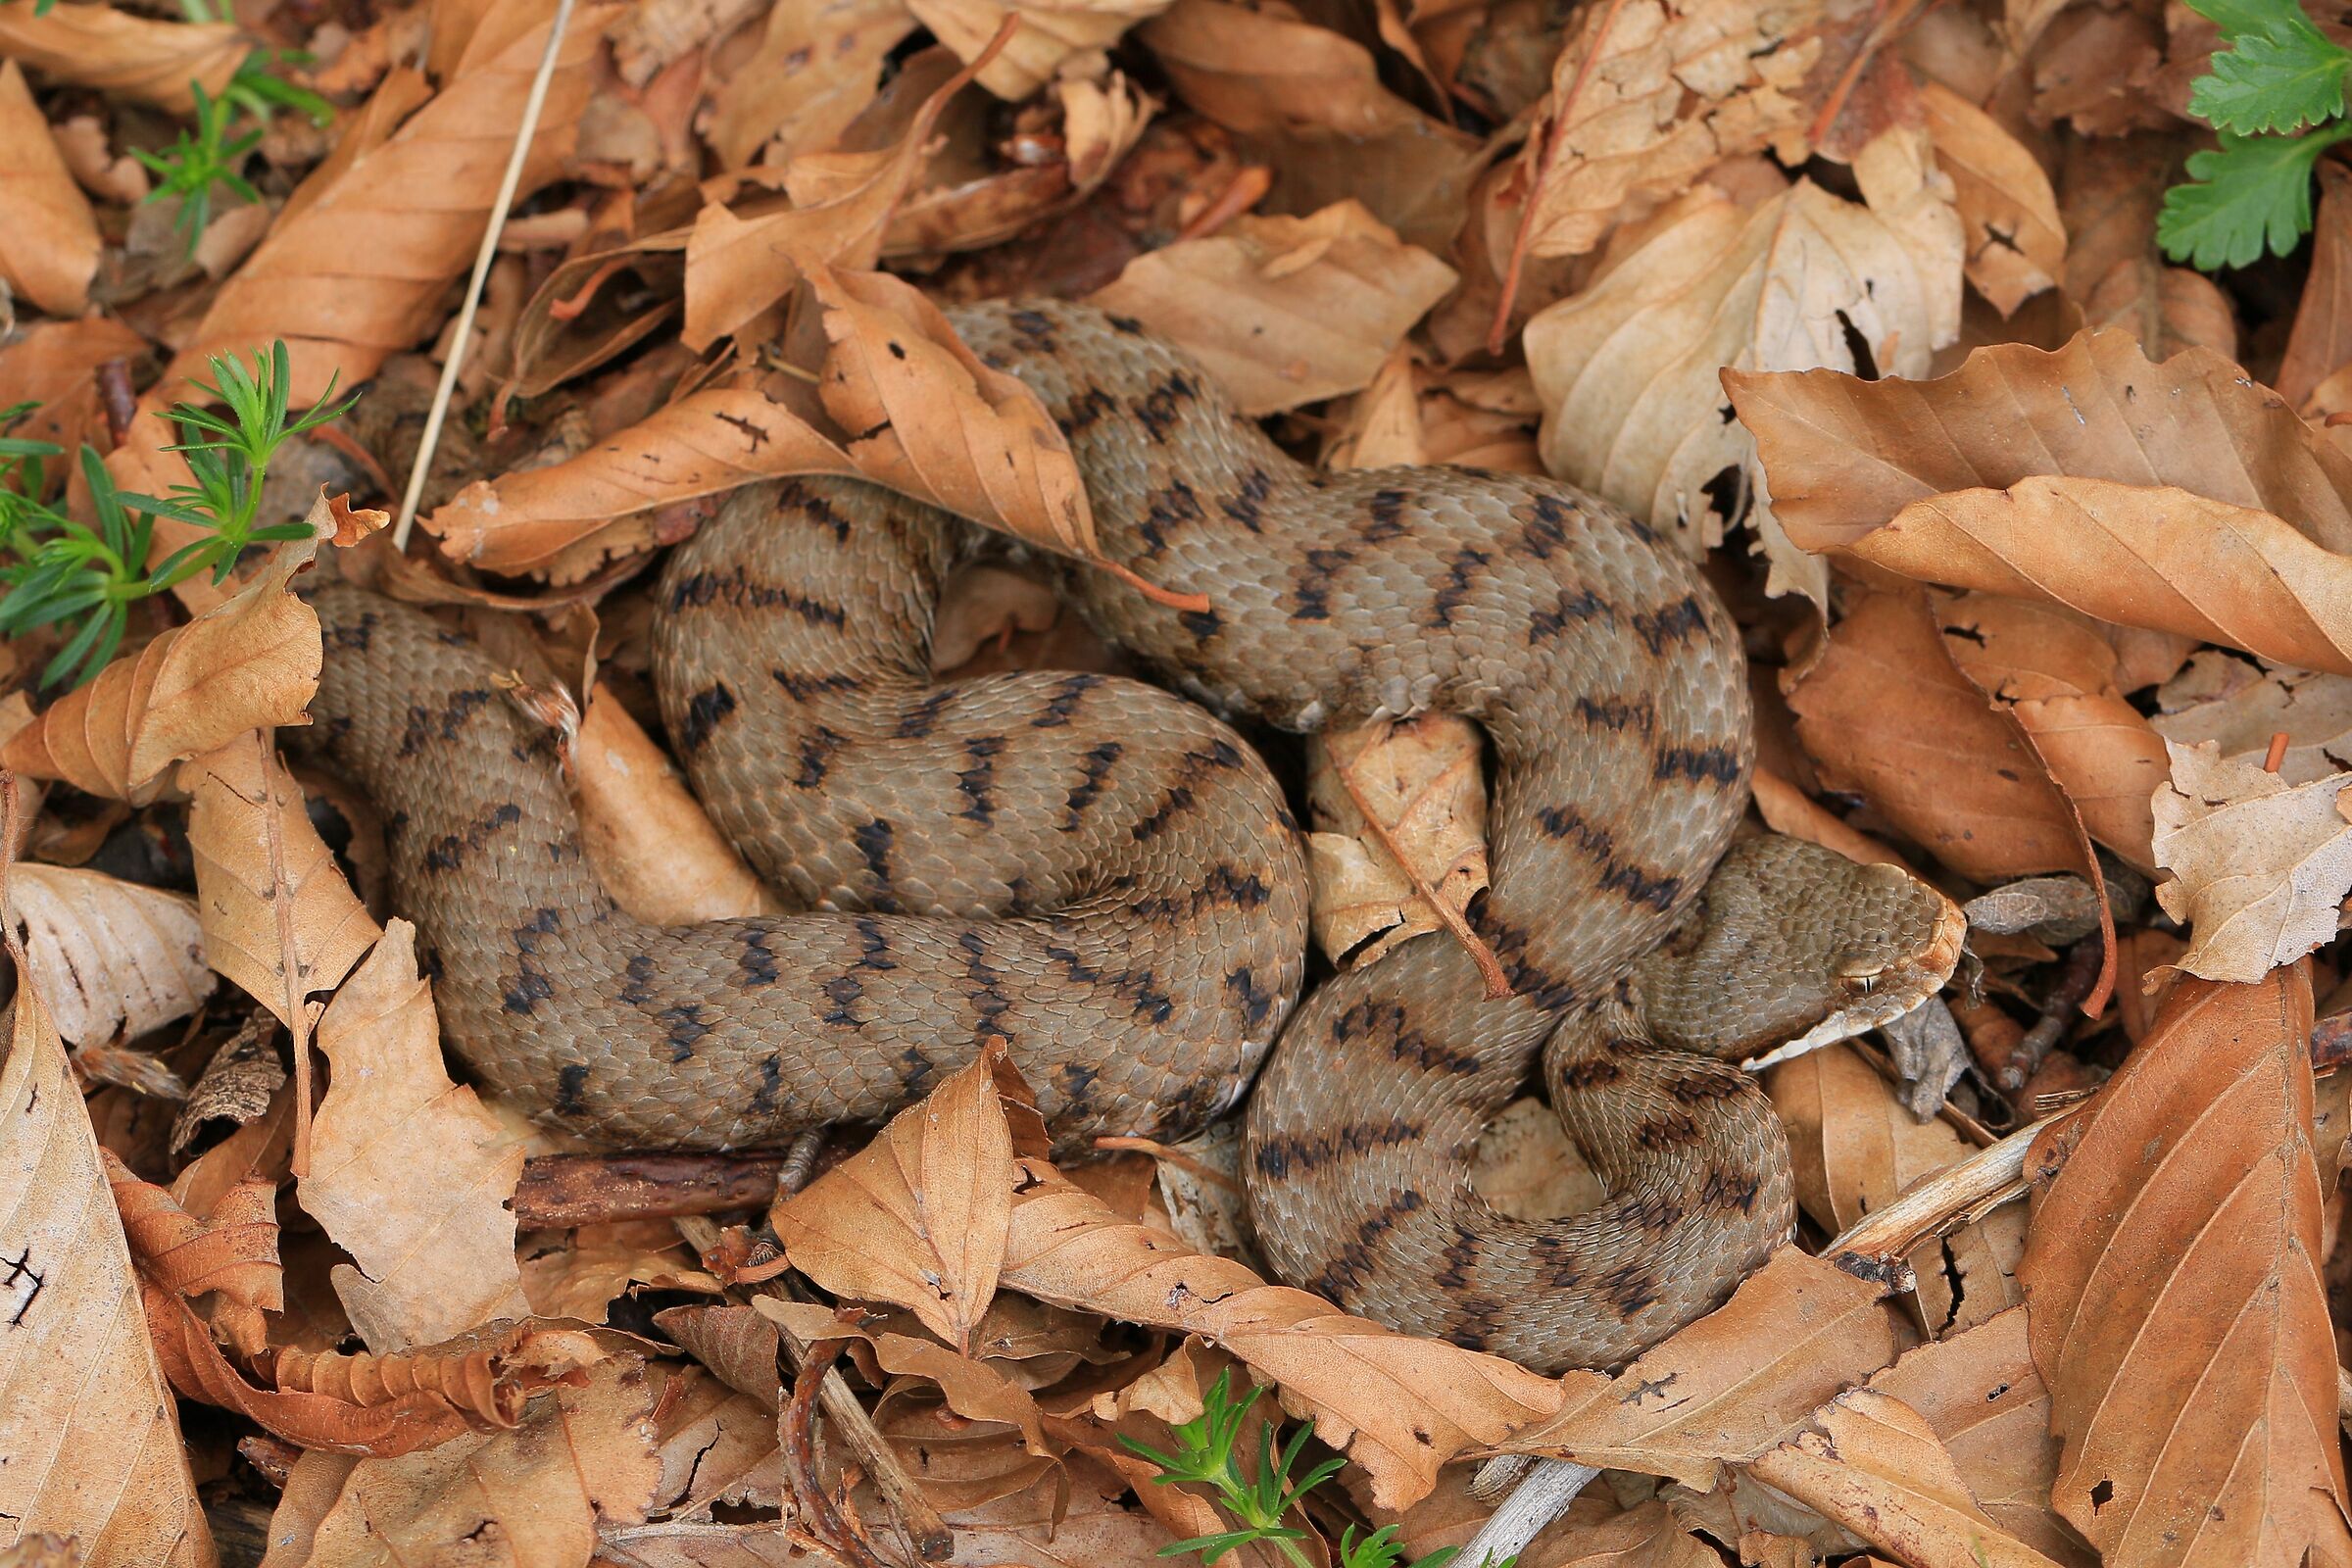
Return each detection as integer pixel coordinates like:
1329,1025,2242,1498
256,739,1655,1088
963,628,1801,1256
0,343,353,684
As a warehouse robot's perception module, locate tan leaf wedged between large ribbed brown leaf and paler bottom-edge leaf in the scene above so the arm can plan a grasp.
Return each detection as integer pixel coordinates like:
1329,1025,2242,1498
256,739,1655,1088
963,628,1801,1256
1870,1304,2091,1568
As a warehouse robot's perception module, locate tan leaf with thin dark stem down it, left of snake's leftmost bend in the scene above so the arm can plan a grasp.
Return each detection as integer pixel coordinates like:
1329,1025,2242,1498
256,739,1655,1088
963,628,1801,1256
178,731,383,1027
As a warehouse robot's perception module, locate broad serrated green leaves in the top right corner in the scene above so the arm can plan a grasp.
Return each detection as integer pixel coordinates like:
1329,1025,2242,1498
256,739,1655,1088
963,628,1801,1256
2157,0,2352,270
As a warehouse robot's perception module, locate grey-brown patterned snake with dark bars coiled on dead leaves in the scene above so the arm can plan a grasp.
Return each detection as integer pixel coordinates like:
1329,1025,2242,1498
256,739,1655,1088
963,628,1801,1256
308,301,1959,1371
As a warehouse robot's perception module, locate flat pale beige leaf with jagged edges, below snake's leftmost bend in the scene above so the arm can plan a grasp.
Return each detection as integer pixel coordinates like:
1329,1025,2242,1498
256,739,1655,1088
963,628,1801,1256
301,919,529,1354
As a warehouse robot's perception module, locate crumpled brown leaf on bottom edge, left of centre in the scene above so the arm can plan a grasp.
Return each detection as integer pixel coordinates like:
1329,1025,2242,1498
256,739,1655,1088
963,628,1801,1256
270,1356,661,1568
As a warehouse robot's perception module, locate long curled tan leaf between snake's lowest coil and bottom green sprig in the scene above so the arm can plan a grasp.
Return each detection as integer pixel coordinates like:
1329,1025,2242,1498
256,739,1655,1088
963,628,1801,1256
1000,1159,1559,1507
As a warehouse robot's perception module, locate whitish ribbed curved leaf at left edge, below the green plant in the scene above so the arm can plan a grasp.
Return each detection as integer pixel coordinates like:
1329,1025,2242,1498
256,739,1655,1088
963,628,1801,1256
10,862,217,1046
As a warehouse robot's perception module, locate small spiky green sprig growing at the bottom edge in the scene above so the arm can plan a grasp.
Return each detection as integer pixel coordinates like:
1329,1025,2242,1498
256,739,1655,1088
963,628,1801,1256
1119,1371,1512,1568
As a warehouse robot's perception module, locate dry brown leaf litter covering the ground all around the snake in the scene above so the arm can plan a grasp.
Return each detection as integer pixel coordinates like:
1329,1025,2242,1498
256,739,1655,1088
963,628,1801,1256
0,0,2352,1568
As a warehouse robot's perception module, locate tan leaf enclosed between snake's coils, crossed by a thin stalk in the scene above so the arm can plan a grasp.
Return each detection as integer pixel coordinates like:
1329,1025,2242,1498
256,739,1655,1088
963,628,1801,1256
1307,712,1487,964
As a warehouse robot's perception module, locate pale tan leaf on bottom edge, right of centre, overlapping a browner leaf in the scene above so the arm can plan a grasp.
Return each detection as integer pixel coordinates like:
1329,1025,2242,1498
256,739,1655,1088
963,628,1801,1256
1747,1390,2056,1568
